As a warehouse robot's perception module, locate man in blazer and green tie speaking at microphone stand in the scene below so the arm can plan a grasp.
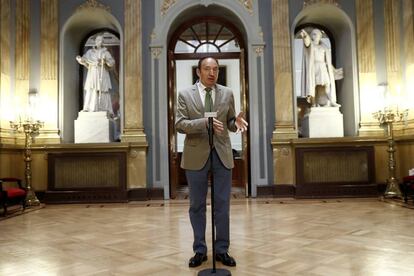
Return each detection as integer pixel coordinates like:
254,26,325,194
175,57,248,267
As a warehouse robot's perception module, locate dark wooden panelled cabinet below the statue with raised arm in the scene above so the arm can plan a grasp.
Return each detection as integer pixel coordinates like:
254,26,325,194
296,146,378,198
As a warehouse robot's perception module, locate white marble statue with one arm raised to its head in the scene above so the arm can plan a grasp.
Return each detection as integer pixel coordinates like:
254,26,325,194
299,29,343,107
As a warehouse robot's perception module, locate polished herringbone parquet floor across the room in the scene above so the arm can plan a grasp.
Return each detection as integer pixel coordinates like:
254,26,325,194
0,199,414,276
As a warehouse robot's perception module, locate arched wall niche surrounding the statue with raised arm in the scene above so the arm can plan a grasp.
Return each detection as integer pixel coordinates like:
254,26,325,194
291,4,359,136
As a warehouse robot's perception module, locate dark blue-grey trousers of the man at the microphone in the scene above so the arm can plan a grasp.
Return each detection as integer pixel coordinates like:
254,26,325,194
185,150,231,254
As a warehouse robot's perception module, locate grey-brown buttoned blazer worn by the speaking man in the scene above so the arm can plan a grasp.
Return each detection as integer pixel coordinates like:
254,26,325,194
175,84,237,170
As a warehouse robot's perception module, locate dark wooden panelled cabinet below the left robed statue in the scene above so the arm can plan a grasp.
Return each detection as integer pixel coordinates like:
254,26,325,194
45,152,128,203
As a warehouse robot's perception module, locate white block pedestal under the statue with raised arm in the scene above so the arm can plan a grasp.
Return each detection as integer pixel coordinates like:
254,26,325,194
302,107,344,138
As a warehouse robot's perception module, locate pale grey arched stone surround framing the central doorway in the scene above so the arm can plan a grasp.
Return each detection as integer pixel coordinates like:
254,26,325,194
150,0,268,199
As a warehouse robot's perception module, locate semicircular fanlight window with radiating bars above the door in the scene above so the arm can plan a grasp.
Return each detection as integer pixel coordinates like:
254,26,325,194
174,18,240,53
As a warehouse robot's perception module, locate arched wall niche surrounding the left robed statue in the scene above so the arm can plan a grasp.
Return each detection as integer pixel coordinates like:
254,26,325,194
59,7,123,143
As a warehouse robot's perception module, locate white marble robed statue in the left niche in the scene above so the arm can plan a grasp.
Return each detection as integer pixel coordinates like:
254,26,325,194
76,34,115,117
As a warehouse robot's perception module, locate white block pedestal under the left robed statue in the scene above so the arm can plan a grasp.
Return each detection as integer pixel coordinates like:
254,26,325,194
75,111,115,143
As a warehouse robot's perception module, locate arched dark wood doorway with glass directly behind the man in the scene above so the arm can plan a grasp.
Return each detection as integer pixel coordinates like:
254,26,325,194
167,16,249,198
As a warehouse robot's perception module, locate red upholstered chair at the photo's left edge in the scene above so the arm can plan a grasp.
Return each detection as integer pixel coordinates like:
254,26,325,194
0,177,27,216
